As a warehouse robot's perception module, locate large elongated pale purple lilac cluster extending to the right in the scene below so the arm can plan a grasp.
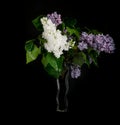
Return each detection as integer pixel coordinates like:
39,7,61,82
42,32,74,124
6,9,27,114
78,32,115,53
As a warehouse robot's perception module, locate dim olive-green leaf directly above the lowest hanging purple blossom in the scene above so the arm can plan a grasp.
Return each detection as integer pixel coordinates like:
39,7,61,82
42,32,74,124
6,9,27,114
73,52,87,67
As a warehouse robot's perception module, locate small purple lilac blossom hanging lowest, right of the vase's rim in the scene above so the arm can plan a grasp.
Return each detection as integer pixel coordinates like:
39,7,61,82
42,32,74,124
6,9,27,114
71,65,81,78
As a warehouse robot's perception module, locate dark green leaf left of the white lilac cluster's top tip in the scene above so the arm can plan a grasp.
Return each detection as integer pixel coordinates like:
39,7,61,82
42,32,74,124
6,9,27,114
32,15,43,32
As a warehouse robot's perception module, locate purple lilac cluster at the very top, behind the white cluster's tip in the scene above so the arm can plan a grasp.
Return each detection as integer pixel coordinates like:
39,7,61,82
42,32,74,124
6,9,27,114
47,12,62,26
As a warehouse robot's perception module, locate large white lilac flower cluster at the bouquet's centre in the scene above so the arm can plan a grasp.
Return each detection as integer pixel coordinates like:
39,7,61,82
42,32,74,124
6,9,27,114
41,17,70,58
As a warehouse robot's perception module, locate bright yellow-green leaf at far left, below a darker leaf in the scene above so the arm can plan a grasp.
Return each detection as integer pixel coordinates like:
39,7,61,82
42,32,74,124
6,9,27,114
26,44,41,64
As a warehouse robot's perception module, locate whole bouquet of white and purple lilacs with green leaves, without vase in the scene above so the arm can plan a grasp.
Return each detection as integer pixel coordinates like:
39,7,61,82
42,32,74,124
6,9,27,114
25,12,115,78
